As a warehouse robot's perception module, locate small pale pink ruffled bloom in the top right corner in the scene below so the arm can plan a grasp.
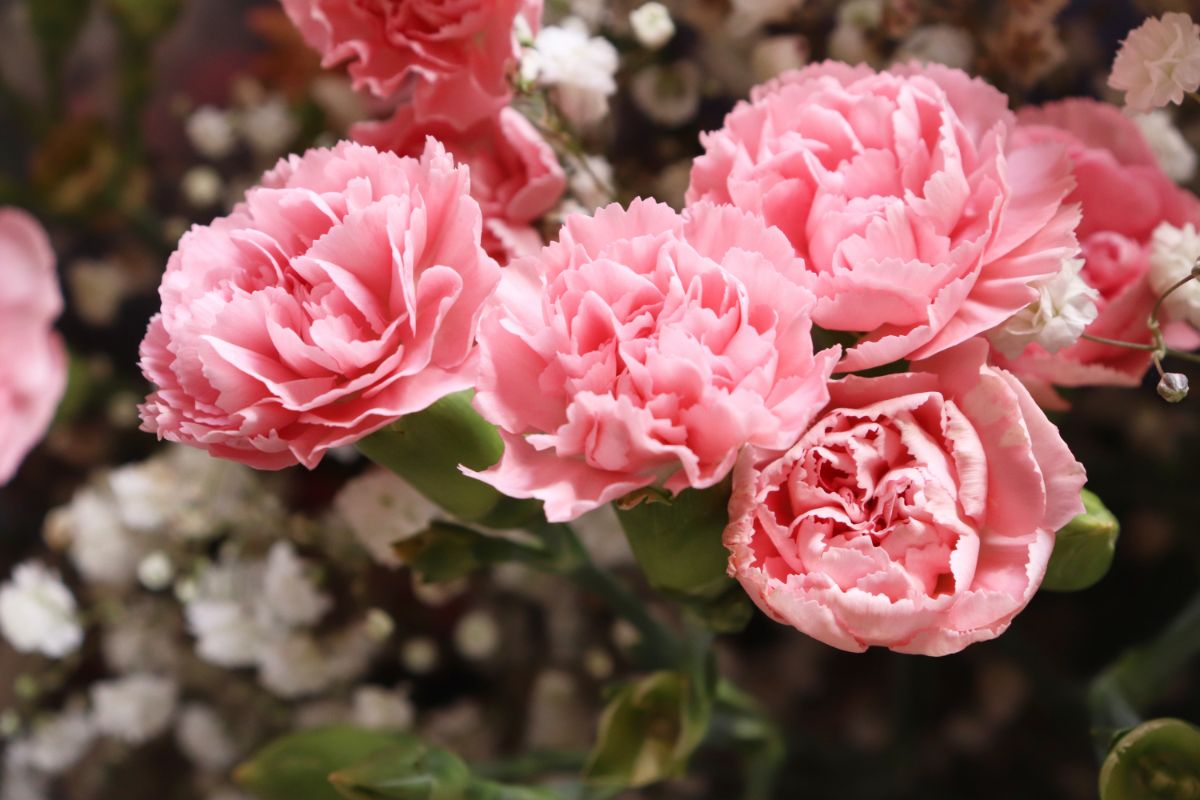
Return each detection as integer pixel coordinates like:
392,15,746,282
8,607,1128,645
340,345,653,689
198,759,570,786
1109,12,1200,112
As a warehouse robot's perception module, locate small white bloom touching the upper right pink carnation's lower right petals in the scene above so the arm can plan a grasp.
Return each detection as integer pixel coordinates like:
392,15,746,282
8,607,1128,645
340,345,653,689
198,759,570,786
988,258,1099,359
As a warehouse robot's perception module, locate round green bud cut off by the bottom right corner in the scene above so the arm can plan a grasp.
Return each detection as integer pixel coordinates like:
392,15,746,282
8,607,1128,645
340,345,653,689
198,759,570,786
1100,720,1200,800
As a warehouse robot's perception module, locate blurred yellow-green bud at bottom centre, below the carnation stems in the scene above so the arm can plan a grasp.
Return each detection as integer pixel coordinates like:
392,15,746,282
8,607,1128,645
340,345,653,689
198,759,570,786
584,672,713,787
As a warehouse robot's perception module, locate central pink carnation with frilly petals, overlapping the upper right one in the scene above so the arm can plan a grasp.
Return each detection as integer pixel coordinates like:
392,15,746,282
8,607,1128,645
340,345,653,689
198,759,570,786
463,200,838,521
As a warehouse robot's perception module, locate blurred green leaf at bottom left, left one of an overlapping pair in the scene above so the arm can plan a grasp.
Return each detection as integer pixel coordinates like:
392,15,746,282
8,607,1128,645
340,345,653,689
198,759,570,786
234,726,420,800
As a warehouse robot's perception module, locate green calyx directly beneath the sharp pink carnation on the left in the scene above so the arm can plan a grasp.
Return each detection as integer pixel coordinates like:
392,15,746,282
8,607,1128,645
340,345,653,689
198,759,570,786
358,391,541,528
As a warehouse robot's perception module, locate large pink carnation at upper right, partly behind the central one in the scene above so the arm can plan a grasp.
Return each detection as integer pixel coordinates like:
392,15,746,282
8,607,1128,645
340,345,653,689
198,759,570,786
688,61,1079,371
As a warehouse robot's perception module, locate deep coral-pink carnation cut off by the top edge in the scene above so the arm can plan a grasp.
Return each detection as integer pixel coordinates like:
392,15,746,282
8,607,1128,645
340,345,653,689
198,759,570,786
282,0,541,127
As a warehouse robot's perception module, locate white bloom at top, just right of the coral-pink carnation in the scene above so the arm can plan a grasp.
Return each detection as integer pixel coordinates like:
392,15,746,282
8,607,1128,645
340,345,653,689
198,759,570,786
521,17,619,127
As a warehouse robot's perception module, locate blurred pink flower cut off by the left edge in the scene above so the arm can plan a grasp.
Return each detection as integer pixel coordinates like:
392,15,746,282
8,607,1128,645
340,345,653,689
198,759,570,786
0,207,67,485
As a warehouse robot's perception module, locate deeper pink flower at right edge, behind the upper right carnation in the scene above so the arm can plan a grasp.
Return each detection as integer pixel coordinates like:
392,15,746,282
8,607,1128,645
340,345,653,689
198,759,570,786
998,98,1200,404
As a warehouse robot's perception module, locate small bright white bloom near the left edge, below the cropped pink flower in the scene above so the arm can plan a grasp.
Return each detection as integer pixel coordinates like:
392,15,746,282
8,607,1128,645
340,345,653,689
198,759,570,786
0,561,83,658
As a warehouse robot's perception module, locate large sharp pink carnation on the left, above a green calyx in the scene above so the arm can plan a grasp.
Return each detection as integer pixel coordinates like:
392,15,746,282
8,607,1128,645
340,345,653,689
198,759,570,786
142,140,499,469
